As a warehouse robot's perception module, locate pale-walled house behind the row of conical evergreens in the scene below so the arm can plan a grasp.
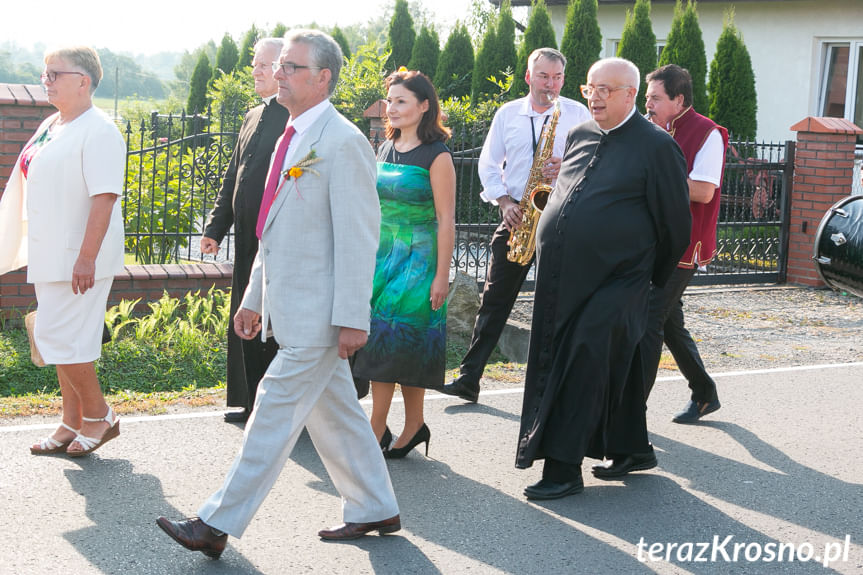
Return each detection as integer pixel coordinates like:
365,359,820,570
500,0,863,141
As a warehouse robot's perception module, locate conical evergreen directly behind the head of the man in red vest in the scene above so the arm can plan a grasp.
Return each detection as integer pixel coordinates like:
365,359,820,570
659,0,708,114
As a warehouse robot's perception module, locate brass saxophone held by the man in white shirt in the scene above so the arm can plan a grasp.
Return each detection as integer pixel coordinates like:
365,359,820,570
506,100,560,266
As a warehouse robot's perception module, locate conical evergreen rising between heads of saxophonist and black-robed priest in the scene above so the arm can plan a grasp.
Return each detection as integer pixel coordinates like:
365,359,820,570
560,0,602,103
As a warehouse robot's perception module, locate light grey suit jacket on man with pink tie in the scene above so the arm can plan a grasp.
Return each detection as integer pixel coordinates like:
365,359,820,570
241,102,381,347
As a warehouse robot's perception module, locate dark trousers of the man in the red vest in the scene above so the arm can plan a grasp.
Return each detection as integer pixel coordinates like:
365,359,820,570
640,268,717,402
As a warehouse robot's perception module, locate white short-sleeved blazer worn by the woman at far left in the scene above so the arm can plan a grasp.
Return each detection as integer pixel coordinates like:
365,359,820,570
0,106,126,283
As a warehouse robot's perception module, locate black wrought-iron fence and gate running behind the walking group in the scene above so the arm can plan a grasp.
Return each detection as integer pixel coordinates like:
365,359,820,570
123,113,794,289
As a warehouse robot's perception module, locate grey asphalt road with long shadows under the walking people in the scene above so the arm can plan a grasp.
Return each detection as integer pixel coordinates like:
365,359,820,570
0,363,863,575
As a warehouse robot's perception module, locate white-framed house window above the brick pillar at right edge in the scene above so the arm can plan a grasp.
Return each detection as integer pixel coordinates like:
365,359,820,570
818,40,863,141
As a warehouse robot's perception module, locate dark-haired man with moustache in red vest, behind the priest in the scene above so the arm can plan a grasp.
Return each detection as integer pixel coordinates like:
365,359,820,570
640,64,728,423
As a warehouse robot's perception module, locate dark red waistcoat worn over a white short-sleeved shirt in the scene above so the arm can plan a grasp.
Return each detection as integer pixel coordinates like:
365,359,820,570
668,106,728,268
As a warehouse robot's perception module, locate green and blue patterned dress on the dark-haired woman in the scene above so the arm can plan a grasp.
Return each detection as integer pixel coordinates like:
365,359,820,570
353,141,449,389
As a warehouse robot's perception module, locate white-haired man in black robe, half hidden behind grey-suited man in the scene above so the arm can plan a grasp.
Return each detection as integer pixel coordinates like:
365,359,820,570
201,38,290,423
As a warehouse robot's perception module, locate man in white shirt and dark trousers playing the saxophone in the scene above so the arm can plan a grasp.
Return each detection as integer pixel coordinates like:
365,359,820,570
443,48,590,403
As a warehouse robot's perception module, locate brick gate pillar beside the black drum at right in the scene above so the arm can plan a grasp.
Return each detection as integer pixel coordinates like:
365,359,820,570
788,117,863,286
